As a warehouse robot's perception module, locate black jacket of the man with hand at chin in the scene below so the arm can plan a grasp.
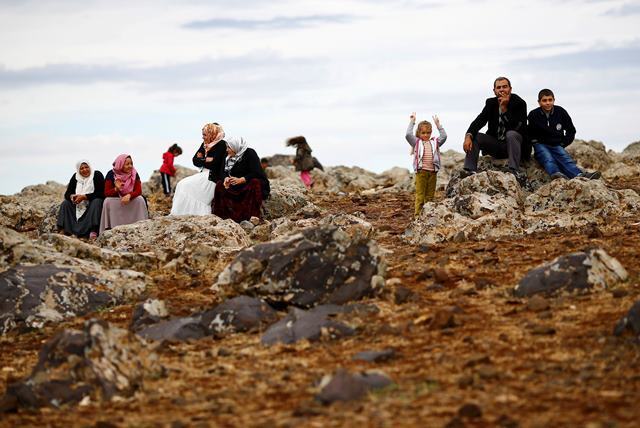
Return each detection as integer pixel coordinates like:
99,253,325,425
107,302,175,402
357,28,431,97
467,94,527,139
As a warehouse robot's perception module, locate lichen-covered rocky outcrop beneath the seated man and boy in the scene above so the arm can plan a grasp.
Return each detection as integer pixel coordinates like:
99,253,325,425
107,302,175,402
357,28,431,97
405,170,640,244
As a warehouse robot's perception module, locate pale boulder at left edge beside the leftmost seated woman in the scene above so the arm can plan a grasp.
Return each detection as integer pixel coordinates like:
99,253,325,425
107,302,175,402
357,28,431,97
0,181,66,232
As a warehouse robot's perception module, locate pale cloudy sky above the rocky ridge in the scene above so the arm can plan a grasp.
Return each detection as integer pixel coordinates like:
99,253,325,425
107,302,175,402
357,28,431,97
0,0,640,195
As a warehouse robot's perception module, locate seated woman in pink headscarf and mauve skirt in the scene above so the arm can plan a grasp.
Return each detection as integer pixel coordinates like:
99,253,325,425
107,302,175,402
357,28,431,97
100,154,149,233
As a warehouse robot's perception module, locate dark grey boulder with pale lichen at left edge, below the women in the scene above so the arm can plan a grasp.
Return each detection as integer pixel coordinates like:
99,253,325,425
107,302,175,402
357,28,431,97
0,264,145,334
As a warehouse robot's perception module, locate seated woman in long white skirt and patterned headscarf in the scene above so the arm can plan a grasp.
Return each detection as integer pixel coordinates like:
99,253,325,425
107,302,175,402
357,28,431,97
171,123,227,215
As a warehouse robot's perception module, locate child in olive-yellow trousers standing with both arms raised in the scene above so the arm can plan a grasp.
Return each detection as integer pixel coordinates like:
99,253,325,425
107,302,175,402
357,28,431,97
406,112,447,217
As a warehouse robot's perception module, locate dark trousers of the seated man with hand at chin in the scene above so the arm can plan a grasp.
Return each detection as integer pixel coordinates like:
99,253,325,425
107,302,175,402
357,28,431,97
464,131,523,171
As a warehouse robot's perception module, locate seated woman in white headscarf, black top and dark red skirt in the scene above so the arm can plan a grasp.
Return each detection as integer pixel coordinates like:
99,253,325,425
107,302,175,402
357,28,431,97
213,137,271,223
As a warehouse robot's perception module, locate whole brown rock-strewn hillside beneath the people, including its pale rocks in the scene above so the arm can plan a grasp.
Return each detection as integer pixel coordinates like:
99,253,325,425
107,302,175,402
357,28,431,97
0,142,640,428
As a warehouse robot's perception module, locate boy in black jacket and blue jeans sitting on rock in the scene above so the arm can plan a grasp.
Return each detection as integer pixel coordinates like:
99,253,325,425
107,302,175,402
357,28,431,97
527,89,601,180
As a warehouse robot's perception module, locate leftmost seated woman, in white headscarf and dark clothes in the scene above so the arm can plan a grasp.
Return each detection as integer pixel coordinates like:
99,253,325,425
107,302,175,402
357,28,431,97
57,160,104,239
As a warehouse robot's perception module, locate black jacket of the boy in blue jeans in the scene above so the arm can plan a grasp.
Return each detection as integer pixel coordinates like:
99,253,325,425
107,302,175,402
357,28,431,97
527,106,576,147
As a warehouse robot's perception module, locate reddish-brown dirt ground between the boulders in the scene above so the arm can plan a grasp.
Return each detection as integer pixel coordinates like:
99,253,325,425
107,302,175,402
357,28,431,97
0,180,640,428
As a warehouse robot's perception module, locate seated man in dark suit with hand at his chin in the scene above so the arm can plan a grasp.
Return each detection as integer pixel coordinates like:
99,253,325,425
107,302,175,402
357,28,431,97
463,77,528,182
